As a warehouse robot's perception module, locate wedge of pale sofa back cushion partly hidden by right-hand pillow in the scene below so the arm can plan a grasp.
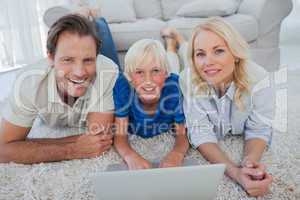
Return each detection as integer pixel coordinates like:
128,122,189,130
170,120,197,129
161,0,195,20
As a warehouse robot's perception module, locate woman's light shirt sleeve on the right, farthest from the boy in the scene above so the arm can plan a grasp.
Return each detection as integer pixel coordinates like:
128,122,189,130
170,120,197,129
245,77,275,145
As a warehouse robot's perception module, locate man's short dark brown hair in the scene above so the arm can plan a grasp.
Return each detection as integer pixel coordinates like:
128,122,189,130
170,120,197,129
47,14,101,55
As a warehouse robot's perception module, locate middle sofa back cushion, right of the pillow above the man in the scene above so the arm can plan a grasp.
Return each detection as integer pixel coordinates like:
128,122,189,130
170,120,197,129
134,0,162,18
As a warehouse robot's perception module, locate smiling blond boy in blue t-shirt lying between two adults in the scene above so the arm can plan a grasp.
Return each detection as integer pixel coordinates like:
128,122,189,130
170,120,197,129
113,39,189,170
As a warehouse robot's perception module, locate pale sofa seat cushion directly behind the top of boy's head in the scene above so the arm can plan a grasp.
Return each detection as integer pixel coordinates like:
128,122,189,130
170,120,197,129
109,18,166,51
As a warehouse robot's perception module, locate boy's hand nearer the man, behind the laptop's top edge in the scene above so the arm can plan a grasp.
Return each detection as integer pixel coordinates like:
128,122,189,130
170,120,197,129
124,153,152,170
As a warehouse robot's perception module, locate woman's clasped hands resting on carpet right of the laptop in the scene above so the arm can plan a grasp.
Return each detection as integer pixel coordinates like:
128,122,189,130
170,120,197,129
236,167,273,197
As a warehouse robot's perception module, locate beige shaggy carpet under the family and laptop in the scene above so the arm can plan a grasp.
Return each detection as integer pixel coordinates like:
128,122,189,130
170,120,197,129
0,68,300,200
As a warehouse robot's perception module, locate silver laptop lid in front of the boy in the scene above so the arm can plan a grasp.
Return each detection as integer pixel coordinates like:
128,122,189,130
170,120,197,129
92,164,225,200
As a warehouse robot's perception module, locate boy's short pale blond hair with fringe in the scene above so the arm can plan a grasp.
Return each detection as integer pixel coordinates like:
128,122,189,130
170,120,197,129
124,39,170,81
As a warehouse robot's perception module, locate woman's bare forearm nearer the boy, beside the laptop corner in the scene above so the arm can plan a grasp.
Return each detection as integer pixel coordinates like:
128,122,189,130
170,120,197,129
198,143,238,180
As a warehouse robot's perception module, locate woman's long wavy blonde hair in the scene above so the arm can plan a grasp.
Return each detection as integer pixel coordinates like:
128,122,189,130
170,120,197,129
187,17,249,110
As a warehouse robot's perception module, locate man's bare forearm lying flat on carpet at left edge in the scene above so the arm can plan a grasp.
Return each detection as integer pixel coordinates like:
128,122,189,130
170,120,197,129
0,140,72,164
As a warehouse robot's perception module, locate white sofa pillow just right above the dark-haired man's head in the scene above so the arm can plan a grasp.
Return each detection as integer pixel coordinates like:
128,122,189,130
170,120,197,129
100,0,136,23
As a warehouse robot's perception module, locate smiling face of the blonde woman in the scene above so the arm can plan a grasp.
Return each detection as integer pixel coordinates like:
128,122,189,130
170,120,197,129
193,30,235,88
